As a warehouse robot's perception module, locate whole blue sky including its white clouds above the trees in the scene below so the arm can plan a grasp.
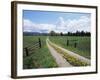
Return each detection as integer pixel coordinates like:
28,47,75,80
23,10,91,33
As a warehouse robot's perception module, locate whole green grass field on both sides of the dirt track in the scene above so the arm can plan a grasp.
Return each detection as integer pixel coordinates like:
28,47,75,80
23,36,91,69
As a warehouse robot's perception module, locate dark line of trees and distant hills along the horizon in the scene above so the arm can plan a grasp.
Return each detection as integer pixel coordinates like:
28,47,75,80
23,31,91,36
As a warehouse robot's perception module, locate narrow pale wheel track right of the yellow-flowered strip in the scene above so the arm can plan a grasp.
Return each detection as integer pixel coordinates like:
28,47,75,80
48,38,91,65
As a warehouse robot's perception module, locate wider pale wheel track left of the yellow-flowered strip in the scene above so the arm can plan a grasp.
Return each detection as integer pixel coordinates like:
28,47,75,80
46,39,72,67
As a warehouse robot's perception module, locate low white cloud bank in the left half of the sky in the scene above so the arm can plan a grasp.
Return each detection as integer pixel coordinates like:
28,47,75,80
23,19,55,33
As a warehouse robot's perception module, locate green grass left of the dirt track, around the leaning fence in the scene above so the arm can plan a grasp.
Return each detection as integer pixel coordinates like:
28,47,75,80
23,36,57,69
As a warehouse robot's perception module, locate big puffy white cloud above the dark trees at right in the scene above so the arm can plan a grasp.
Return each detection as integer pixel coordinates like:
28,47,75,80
66,16,91,32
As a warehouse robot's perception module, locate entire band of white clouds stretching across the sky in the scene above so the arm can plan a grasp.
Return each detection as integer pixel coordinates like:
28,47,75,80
23,16,91,33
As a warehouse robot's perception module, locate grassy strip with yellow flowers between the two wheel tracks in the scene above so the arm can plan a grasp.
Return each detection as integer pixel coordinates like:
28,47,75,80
49,42,90,66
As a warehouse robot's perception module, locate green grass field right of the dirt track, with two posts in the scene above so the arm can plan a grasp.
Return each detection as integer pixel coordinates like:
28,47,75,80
49,36,91,59
